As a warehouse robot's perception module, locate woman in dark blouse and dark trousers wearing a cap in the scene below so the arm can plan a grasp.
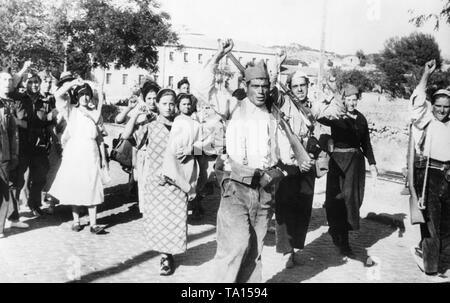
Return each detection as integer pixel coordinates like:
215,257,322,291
318,85,378,256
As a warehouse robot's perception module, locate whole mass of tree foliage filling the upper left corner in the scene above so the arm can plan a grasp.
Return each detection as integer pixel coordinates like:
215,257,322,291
0,0,177,76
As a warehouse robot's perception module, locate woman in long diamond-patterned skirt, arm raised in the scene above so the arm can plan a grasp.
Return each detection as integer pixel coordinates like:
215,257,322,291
122,89,194,275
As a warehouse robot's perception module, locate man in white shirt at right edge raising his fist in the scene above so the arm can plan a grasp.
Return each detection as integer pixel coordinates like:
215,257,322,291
411,60,450,275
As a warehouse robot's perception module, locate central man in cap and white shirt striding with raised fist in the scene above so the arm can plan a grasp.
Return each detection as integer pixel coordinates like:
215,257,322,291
196,40,288,282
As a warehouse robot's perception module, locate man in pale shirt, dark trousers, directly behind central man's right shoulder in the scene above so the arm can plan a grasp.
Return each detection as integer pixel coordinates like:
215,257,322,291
275,71,341,268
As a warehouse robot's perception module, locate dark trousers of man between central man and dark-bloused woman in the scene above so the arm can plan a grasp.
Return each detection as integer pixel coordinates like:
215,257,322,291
275,171,315,254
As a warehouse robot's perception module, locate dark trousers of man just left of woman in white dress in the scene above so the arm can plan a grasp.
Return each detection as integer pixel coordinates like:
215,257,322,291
9,150,50,220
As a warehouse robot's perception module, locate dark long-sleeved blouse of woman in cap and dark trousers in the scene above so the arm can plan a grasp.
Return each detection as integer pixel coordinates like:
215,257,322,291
318,111,376,165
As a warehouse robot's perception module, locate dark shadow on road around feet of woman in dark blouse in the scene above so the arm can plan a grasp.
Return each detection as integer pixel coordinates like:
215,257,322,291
267,209,397,283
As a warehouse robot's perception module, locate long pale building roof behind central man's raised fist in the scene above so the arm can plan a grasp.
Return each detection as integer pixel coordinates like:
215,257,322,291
166,34,276,55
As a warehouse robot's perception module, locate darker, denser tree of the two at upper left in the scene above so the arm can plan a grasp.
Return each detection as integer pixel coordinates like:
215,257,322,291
56,0,177,76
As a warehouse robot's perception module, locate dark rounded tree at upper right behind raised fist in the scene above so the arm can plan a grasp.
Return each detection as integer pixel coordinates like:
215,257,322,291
375,33,442,97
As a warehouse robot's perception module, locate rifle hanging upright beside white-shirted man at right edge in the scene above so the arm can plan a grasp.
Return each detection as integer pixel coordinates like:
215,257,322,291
407,123,425,224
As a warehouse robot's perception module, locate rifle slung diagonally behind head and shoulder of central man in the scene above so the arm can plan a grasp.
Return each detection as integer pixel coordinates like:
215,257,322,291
227,52,311,166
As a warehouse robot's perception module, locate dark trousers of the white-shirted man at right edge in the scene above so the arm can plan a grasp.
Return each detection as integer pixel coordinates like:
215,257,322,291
417,169,450,273
